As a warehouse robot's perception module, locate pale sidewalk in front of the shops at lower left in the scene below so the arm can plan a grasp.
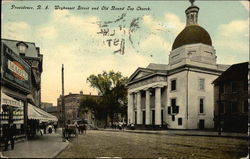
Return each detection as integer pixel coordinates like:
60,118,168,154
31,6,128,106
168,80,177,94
3,129,69,158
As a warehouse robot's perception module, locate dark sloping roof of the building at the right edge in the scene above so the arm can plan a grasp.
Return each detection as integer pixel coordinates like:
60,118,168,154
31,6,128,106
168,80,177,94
213,62,248,84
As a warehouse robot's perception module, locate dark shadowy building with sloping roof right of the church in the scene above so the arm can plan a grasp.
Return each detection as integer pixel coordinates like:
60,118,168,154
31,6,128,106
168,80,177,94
213,62,249,132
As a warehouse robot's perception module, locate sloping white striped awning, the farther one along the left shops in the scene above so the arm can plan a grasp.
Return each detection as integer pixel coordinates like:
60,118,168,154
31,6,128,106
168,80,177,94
28,103,58,122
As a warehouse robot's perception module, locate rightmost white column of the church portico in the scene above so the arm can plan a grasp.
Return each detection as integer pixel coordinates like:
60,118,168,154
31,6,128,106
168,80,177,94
155,87,161,125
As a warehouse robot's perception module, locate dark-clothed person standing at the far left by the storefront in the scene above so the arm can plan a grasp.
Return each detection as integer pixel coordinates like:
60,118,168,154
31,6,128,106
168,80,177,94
4,124,16,151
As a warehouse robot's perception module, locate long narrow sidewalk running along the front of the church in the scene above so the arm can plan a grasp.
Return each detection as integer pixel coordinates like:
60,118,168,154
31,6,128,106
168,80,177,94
99,128,248,139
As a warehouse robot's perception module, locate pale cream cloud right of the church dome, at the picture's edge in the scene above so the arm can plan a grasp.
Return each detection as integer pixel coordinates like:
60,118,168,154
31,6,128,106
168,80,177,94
213,18,249,64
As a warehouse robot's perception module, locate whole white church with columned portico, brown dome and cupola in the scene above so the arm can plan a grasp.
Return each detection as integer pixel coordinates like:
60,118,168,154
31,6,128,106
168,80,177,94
127,1,229,129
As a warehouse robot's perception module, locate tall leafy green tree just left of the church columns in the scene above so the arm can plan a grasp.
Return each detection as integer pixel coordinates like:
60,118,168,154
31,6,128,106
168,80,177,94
87,71,127,122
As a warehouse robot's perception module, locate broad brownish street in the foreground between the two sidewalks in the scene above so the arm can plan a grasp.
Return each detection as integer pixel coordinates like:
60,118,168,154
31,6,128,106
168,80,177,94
57,130,248,159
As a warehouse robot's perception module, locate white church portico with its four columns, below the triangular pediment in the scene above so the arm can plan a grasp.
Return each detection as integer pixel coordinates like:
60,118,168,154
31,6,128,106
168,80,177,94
128,79,167,125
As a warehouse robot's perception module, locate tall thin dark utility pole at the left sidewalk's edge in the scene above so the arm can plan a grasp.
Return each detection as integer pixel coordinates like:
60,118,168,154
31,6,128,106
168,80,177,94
61,64,66,141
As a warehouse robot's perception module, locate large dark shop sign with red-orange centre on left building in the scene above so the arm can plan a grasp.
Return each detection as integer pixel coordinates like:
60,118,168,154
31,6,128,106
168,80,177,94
1,43,31,92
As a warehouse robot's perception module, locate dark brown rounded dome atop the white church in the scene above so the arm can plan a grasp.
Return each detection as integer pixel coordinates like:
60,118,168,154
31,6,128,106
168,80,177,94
172,25,212,50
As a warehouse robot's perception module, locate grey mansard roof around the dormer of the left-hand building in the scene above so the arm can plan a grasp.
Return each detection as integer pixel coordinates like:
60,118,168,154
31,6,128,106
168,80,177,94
1,39,38,57
